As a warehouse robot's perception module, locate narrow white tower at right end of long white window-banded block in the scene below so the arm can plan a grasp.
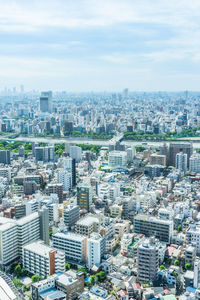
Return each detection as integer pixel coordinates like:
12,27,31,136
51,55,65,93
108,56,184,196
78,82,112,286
87,233,105,269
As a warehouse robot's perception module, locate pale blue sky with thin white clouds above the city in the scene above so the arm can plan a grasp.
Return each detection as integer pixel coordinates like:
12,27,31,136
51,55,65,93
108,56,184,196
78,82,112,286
0,0,200,92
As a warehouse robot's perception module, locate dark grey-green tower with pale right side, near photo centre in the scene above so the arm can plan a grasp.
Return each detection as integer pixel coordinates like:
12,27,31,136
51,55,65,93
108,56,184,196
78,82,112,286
77,184,92,211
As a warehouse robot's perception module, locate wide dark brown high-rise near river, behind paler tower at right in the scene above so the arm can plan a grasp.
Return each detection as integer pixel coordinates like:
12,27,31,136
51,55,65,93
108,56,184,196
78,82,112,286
169,143,193,167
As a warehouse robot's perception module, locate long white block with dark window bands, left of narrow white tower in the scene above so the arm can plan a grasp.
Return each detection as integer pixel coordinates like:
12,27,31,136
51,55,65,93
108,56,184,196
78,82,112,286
52,232,87,263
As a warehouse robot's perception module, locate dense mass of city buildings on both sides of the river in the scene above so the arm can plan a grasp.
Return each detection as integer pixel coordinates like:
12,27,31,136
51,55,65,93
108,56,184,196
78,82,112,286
0,91,200,300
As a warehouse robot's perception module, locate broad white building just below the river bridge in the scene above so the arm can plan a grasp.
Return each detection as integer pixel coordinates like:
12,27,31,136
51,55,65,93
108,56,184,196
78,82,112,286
108,151,127,168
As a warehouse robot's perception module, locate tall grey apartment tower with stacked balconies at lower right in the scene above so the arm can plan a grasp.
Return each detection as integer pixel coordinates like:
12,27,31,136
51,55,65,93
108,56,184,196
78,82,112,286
137,238,160,282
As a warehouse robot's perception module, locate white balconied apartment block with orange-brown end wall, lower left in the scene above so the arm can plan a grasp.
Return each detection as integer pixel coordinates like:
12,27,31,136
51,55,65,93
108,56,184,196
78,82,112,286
22,240,65,278
